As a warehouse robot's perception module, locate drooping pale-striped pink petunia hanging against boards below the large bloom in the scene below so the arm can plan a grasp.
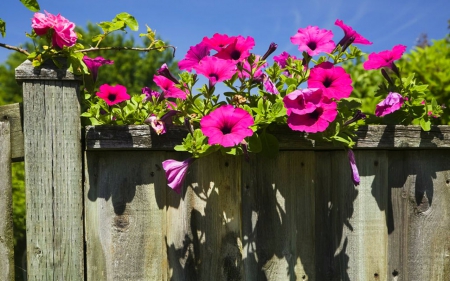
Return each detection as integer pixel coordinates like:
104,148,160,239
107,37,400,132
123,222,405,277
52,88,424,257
162,158,194,194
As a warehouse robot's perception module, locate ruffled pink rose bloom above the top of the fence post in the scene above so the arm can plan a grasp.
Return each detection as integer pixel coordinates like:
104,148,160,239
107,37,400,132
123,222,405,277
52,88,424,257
31,11,77,48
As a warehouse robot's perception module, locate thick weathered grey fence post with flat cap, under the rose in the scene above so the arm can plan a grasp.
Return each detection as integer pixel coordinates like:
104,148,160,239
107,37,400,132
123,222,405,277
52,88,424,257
16,61,84,280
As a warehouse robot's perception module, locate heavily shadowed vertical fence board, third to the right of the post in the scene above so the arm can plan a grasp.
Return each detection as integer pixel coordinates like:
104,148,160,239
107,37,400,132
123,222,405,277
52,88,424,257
242,151,317,280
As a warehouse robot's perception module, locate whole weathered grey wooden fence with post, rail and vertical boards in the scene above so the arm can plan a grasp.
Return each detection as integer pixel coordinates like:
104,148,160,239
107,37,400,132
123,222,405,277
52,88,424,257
0,60,450,281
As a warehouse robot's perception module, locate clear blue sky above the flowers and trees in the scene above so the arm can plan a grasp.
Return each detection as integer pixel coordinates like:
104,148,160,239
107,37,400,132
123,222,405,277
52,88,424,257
0,0,450,62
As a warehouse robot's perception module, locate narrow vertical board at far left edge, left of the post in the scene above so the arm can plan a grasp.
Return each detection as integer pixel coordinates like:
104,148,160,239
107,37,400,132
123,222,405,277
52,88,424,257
0,121,15,281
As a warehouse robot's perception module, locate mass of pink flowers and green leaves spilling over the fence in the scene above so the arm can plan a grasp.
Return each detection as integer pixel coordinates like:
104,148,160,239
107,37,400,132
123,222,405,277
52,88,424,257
0,7,442,193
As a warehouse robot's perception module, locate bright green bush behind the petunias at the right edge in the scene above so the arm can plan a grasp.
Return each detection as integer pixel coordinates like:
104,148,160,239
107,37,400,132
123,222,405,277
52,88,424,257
343,35,450,123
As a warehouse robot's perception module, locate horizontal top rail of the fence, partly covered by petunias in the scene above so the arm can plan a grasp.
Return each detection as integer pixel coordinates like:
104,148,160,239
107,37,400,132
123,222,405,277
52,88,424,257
86,125,450,150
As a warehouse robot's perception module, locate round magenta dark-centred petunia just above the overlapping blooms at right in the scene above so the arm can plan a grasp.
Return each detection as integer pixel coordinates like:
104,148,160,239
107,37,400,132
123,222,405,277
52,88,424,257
308,62,353,100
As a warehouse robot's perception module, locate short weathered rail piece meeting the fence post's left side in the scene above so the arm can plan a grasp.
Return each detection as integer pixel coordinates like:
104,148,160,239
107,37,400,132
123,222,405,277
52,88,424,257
0,103,23,162
